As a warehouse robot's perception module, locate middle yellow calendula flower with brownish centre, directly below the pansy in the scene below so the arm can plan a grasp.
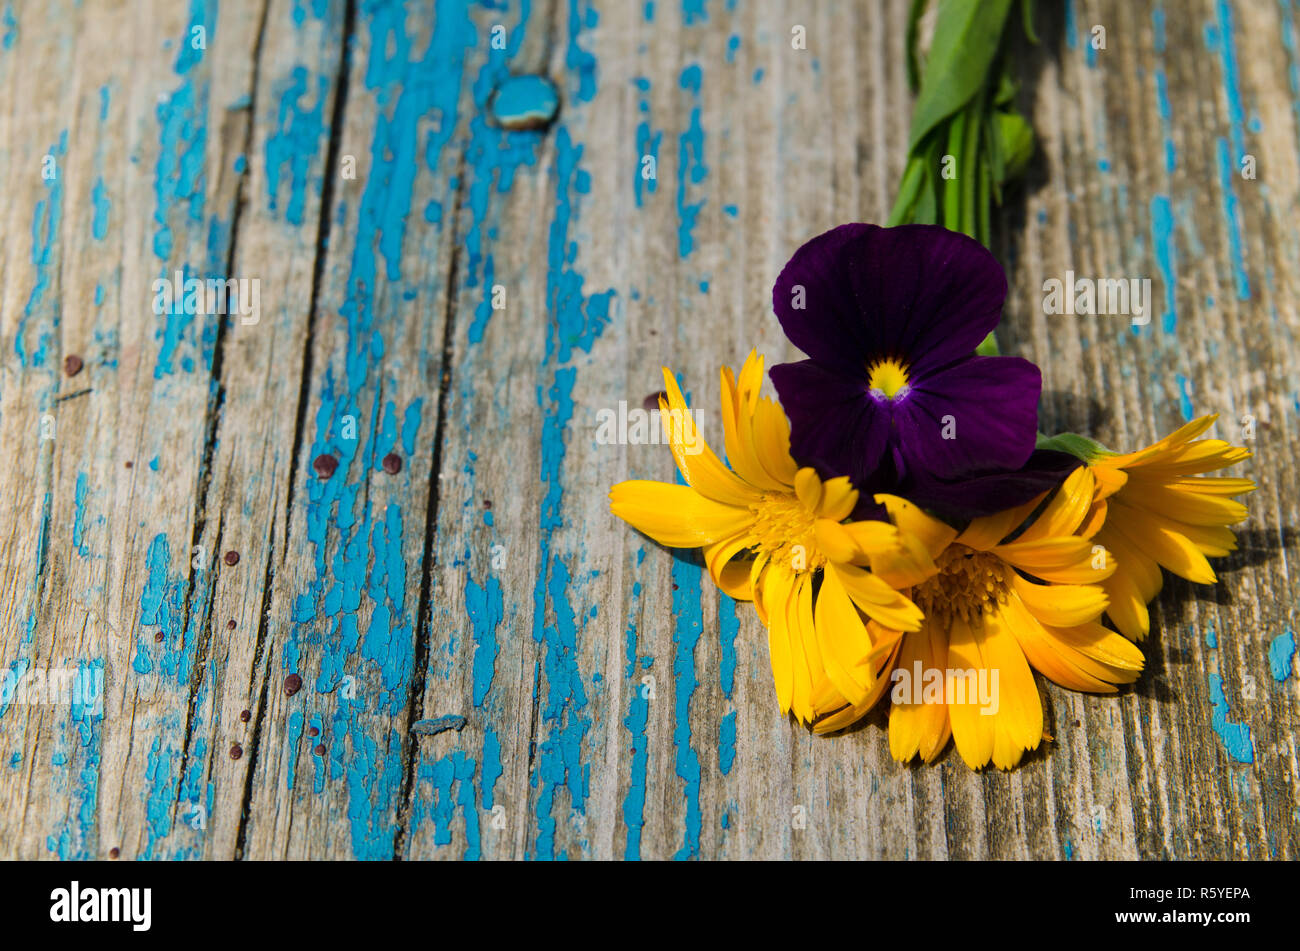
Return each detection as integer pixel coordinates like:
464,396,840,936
814,466,1143,769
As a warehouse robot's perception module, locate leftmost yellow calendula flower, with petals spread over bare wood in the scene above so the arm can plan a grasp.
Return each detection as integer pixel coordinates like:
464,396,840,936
610,351,920,722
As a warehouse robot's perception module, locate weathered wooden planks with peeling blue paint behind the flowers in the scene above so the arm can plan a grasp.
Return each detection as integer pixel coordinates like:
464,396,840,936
0,0,1300,859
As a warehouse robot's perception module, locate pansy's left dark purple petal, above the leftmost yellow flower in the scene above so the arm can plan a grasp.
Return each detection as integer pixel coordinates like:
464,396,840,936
770,360,889,485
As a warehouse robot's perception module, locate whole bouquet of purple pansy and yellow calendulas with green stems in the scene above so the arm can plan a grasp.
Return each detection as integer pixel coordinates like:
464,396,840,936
610,1,1255,769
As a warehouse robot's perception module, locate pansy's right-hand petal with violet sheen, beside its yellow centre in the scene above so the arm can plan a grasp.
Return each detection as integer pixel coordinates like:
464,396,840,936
894,357,1043,479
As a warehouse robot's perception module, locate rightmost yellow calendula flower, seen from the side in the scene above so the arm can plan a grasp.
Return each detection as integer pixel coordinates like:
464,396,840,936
1088,414,1255,640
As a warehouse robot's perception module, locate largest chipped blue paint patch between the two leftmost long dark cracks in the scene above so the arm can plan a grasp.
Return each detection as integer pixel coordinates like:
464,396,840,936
265,66,330,226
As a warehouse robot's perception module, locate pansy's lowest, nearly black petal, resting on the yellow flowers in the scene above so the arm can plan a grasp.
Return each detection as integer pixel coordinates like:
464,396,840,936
889,450,1082,521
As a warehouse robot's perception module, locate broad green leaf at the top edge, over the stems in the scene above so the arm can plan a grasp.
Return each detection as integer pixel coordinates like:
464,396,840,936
909,0,1011,149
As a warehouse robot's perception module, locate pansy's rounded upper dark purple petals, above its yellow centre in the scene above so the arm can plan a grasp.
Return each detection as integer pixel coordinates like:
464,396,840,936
772,223,1006,377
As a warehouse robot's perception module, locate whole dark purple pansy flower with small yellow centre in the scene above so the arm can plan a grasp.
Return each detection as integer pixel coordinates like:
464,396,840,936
771,225,1078,518
